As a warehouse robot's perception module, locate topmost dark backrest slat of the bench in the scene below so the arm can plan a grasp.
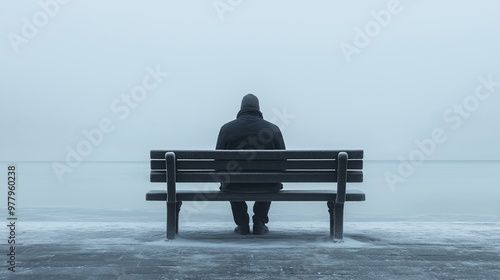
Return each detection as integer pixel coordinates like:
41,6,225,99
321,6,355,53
150,150,363,160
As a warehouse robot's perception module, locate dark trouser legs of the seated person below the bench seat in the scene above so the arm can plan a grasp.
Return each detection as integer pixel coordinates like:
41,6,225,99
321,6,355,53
231,201,271,226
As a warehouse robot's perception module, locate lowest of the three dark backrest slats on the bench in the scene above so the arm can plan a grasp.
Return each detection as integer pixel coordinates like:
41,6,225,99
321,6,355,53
150,171,363,183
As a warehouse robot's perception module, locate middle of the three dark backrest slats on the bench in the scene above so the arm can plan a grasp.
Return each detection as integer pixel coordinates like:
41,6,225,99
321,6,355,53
151,159,363,171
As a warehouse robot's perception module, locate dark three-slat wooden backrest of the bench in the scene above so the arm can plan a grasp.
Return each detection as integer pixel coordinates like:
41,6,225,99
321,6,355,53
150,150,363,183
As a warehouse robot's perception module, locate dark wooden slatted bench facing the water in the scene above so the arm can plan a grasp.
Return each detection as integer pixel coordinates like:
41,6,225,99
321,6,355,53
146,150,365,241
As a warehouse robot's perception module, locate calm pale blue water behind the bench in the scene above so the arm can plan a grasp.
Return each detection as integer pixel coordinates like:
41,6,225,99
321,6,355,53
0,161,500,217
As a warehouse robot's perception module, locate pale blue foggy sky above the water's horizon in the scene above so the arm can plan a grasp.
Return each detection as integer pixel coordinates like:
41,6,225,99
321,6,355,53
0,0,500,162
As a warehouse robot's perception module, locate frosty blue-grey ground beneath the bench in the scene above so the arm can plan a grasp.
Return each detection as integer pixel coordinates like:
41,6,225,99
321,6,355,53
0,208,500,279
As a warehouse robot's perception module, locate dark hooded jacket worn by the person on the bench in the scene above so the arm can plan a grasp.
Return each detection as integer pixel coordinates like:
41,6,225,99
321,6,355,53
216,94,285,193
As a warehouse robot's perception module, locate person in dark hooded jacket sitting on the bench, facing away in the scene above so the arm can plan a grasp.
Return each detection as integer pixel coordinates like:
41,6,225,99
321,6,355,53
216,94,285,235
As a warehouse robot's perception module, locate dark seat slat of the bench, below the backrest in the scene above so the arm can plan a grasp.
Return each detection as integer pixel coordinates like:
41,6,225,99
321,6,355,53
146,190,365,201
